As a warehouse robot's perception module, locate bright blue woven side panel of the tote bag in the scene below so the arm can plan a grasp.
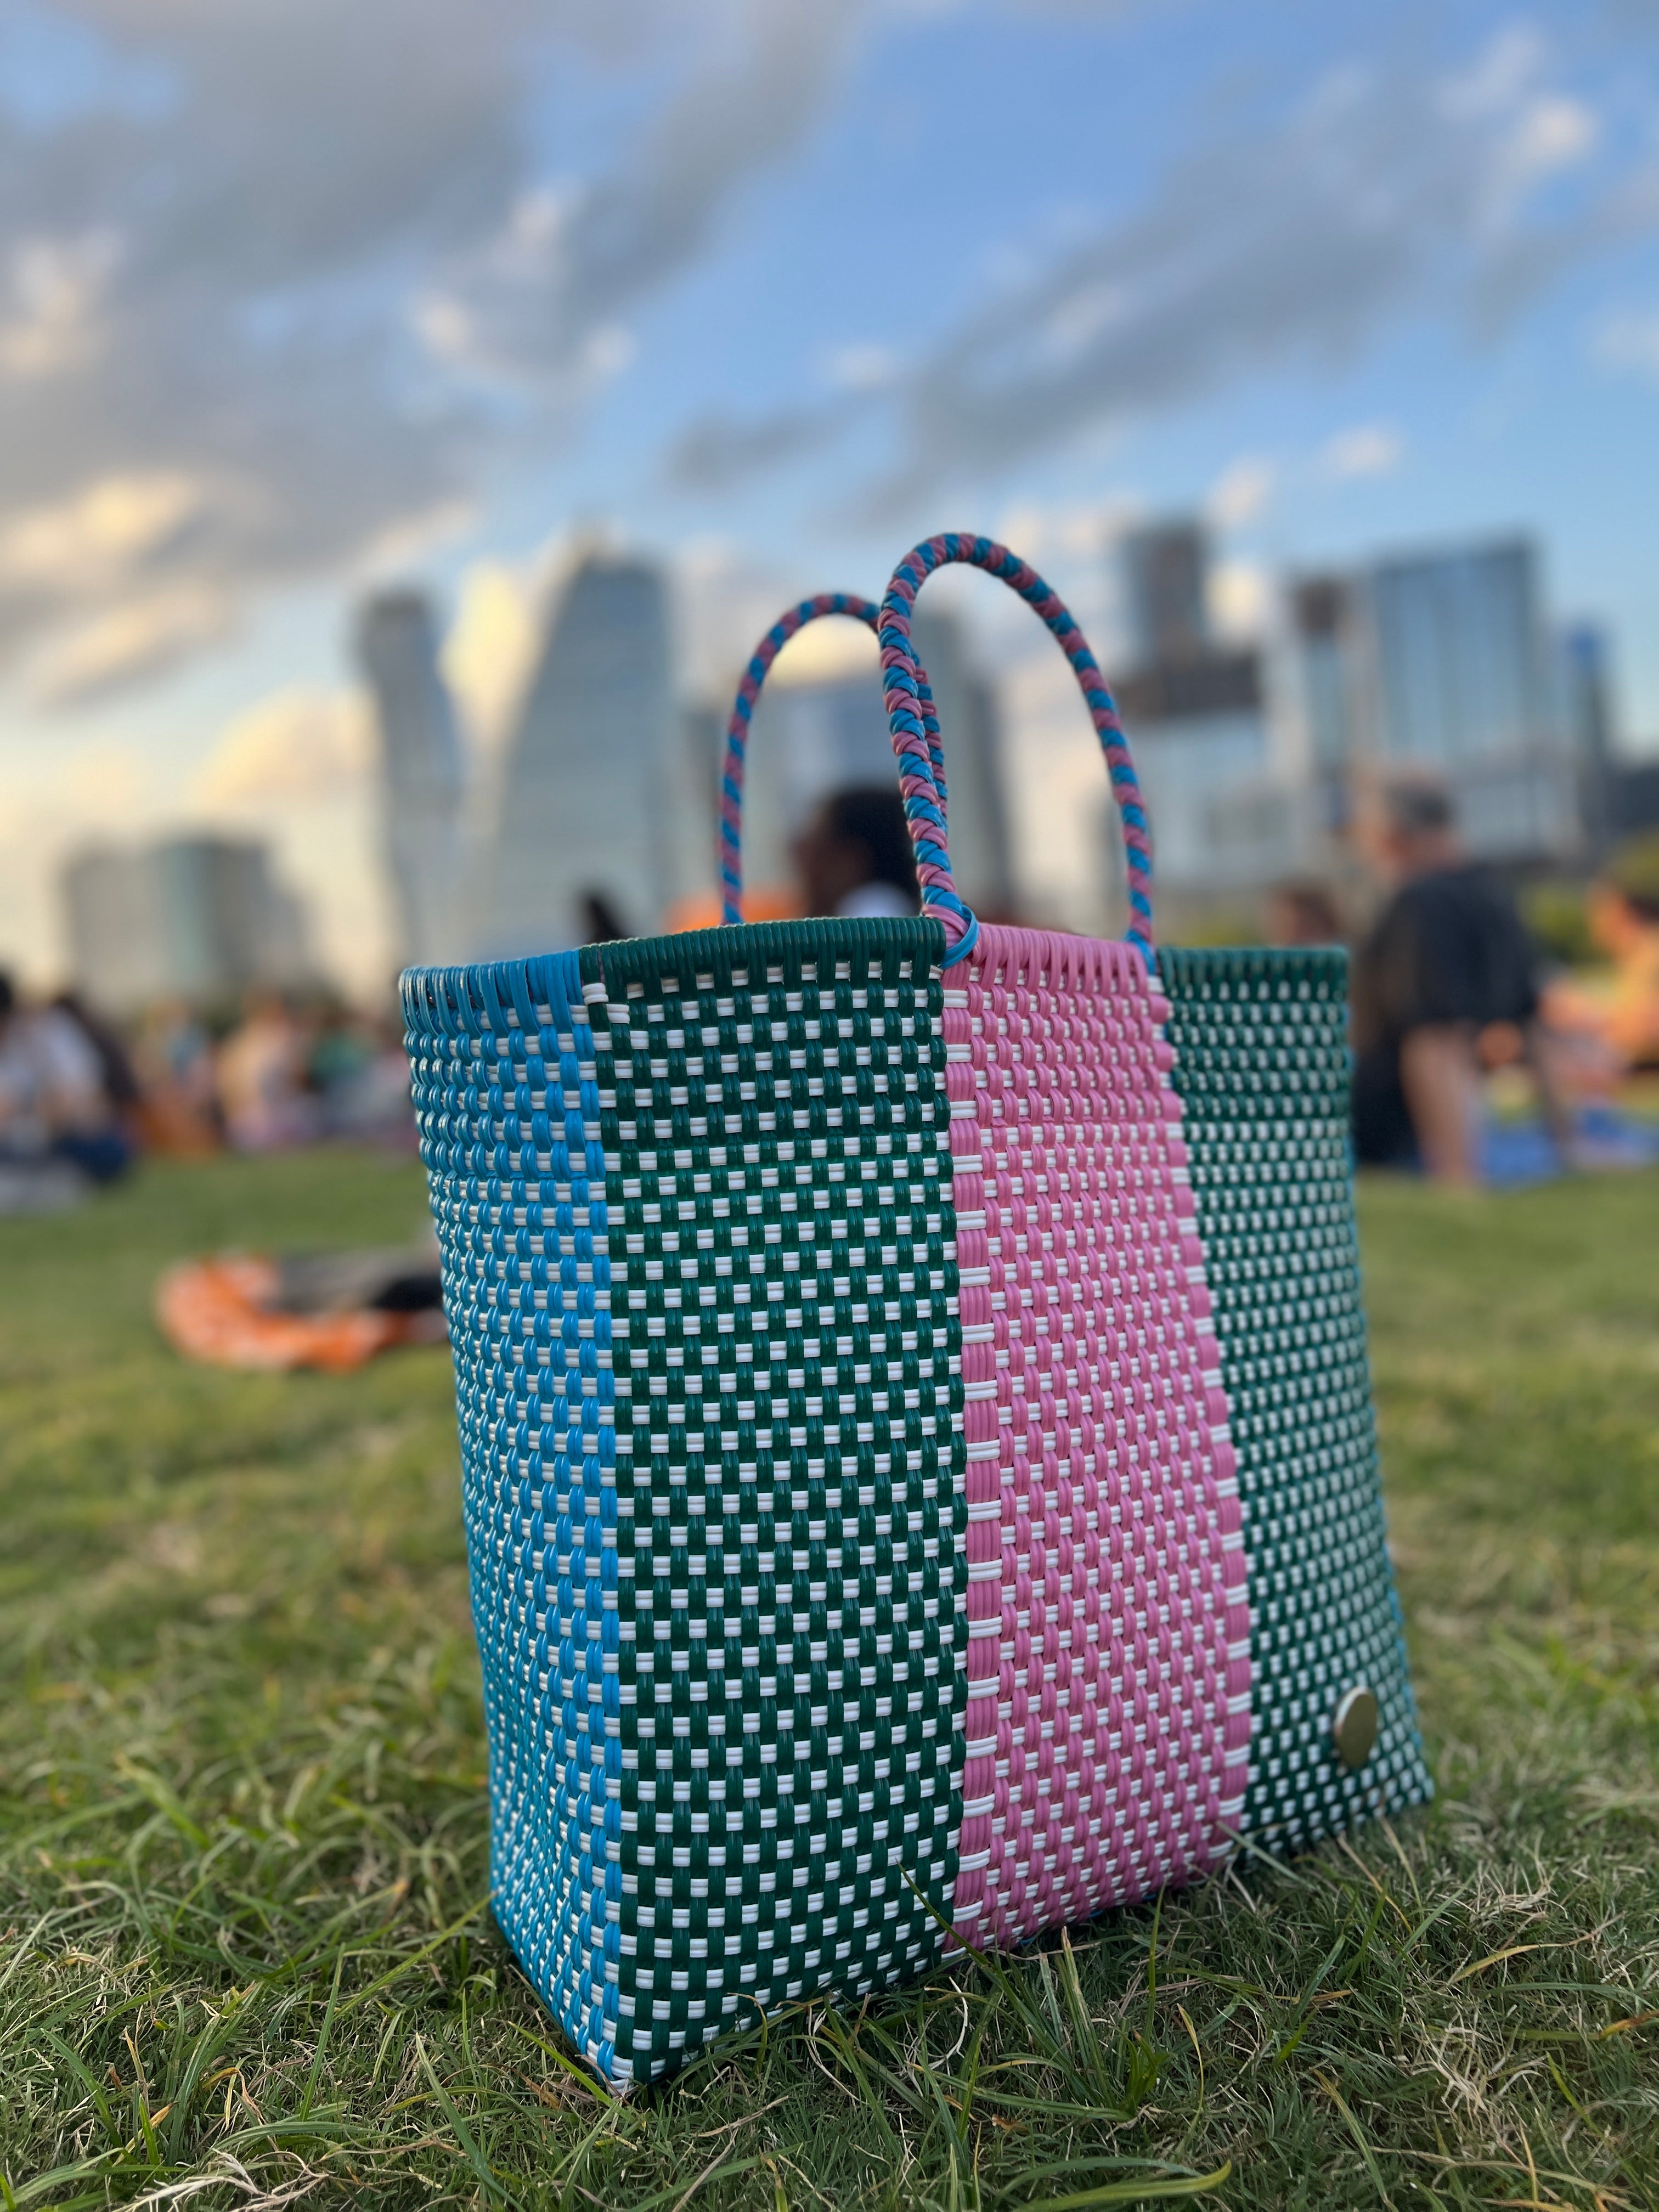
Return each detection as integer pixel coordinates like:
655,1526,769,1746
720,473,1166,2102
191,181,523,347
403,953,622,2064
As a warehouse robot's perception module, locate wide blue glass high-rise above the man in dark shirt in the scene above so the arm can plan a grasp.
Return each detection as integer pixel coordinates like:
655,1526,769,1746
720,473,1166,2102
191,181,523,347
1290,540,1606,862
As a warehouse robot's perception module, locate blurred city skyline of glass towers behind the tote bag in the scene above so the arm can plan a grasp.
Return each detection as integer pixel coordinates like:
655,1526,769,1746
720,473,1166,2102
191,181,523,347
42,502,1650,1005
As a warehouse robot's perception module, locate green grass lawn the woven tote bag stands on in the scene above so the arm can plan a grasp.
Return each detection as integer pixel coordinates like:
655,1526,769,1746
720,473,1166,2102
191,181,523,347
0,1155,1659,2212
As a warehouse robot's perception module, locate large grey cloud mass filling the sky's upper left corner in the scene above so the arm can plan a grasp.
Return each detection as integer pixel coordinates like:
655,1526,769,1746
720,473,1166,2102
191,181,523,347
0,0,862,697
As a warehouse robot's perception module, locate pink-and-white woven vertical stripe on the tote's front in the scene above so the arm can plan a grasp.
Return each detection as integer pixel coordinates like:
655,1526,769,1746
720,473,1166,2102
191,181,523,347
945,927,1250,1944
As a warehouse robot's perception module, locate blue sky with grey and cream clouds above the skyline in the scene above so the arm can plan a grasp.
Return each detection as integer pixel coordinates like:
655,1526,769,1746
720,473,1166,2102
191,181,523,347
0,0,1659,978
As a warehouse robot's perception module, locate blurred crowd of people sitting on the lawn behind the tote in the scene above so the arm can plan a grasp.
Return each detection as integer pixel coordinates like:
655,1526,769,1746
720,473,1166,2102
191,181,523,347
0,796,1659,1212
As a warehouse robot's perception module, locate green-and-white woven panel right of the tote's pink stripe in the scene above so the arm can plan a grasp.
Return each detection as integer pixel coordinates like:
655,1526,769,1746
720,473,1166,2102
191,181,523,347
1159,951,1431,1849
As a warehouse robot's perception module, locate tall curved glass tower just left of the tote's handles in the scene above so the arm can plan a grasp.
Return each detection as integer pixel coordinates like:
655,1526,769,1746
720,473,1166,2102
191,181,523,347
476,551,681,958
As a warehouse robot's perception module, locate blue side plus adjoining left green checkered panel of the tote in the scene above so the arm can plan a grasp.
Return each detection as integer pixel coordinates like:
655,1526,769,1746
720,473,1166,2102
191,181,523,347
405,920,967,2079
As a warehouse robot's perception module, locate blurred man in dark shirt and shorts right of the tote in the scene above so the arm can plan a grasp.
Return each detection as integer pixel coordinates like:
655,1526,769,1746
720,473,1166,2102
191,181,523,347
1354,776,1571,1188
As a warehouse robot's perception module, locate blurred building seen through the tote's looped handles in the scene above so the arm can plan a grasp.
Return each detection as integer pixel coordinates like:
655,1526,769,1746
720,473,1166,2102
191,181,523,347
738,608,1013,913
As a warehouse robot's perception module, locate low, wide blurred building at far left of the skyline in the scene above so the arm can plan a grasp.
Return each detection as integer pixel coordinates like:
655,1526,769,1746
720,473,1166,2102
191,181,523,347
60,836,314,1013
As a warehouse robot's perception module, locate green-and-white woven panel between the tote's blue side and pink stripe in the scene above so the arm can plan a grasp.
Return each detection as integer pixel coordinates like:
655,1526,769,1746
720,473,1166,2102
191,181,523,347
582,920,967,2077
